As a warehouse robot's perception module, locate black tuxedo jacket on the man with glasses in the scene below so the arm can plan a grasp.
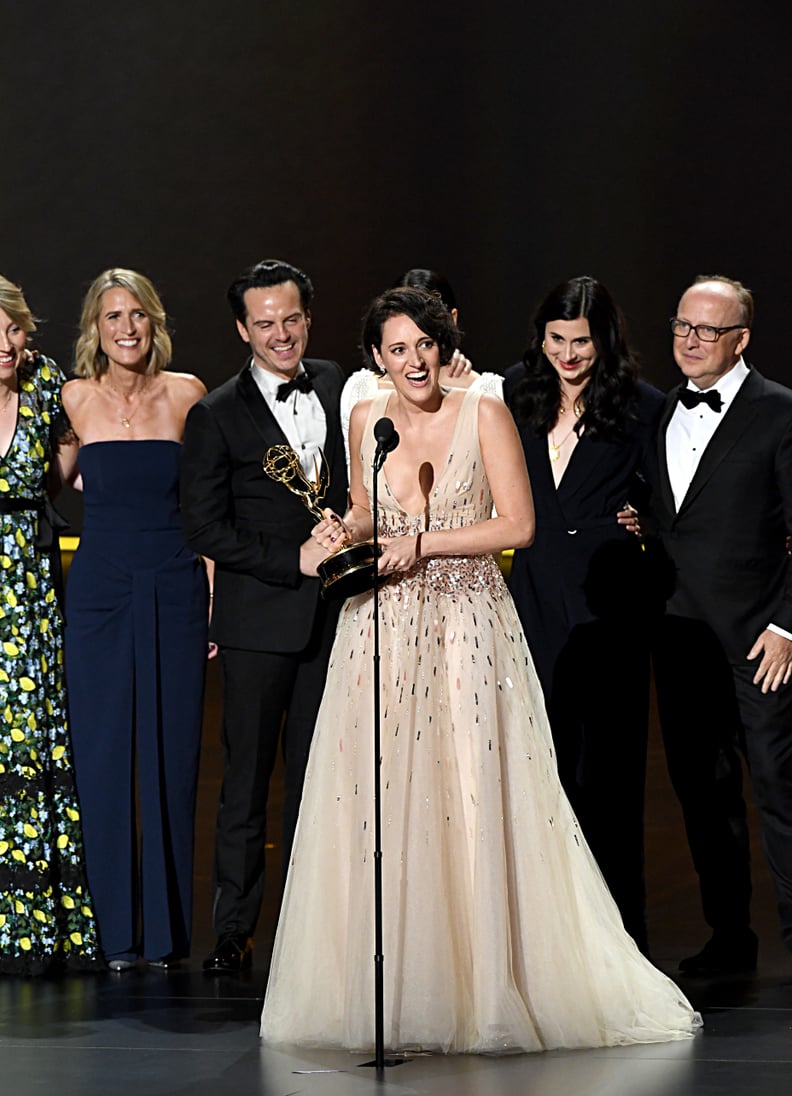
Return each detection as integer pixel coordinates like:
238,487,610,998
653,369,792,662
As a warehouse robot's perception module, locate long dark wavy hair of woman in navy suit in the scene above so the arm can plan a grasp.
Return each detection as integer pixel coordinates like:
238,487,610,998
509,275,638,441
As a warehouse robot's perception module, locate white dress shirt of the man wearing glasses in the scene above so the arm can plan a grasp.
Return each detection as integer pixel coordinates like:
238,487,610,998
666,357,792,653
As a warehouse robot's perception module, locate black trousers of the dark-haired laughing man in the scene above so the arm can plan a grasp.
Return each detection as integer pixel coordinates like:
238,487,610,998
213,604,337,936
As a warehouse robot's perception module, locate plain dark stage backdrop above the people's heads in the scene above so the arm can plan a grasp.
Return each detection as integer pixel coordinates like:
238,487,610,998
6,0,792,418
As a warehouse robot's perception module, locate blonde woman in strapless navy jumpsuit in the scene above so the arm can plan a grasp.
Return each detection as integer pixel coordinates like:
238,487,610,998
64,269,208,971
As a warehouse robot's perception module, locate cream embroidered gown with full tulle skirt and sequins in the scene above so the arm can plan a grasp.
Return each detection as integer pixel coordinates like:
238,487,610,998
261,391,698,1052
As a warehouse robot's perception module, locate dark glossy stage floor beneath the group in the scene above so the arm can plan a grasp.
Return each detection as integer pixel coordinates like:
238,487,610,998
0,666,792,1096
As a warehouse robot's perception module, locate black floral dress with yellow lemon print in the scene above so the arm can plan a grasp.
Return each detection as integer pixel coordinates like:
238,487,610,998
0,354,101,974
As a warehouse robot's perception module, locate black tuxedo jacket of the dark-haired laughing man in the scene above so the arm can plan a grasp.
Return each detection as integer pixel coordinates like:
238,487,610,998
181,358,347,652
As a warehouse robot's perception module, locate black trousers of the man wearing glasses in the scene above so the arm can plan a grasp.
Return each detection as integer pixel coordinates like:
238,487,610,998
654,616,792,947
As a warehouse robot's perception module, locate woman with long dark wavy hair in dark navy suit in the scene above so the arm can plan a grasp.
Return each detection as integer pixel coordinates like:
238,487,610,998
505,277,663,951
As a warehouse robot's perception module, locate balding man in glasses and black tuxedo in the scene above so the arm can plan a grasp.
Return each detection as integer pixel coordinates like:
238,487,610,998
655,276,792,974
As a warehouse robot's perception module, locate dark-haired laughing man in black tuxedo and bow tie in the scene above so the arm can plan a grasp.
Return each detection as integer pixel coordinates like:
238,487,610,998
182,260,347,973
